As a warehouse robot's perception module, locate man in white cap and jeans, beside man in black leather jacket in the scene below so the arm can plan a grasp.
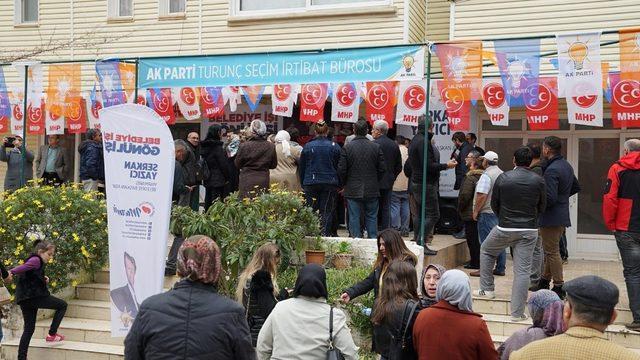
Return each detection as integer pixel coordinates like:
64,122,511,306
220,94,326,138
467,151,507,276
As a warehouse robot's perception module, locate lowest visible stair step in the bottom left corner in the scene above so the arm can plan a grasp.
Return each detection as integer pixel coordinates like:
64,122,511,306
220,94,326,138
1,338,124,360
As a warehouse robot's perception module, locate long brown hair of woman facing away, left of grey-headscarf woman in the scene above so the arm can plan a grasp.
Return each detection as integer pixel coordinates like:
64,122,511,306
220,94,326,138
371,260,418,325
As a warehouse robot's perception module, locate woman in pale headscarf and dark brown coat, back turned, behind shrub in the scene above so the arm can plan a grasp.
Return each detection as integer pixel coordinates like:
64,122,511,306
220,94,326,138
235,120,278,198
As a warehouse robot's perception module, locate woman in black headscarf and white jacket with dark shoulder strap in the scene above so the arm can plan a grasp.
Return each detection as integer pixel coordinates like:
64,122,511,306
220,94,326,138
256,264,358,360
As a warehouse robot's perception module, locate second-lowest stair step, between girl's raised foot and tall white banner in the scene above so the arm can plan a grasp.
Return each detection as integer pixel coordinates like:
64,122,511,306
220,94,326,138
33,317,122,345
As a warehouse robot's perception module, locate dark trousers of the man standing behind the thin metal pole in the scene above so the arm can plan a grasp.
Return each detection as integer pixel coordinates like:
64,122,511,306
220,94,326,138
409,182,440,245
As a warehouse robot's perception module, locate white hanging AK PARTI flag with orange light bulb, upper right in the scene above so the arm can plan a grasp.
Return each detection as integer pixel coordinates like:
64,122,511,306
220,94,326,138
556,32,602,99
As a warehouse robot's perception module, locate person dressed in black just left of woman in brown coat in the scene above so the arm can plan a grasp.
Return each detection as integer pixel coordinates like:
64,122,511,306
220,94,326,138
200,125,230,211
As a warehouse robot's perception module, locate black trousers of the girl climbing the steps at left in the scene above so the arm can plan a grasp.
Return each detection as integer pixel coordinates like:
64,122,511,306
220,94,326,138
18,295,67,360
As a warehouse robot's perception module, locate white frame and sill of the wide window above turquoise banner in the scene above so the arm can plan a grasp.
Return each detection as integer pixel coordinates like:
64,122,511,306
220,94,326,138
229,0,394,16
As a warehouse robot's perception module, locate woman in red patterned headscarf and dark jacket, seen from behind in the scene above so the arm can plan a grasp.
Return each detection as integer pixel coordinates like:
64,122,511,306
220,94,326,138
124,235,255,360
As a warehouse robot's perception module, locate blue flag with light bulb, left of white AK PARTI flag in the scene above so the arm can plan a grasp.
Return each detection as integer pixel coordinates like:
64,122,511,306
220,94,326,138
494,39,540,107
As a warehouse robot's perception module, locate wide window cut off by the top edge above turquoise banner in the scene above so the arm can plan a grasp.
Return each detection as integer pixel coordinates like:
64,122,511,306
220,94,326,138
234,0,382,13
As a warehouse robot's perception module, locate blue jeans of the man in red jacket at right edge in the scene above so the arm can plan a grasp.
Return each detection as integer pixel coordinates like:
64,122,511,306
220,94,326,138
615,231,640,322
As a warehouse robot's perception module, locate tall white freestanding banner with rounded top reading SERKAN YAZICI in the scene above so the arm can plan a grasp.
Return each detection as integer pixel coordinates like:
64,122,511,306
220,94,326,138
100,104,175,337
